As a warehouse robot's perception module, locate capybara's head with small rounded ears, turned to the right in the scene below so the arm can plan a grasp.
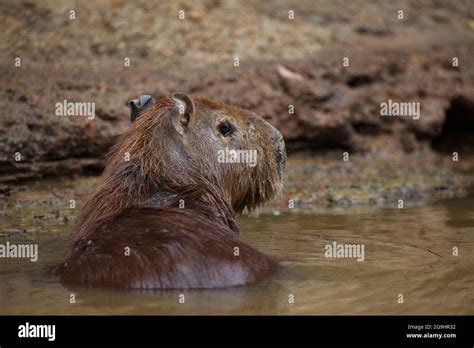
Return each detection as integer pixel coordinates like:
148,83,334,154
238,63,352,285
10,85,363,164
115,93,286,213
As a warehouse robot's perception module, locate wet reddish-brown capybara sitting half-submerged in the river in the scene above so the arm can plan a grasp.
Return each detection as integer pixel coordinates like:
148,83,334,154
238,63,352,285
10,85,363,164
56,93,286,289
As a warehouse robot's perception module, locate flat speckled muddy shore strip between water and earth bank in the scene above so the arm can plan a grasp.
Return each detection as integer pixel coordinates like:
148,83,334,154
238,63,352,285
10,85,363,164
0,151,474,235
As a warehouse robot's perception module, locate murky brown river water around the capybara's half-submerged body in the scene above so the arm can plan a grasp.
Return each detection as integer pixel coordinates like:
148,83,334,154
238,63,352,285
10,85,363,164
0,197,474,314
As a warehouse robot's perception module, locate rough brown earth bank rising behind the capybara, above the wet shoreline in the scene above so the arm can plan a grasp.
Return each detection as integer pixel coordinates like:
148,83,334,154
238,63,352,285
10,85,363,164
0,0,474,181
